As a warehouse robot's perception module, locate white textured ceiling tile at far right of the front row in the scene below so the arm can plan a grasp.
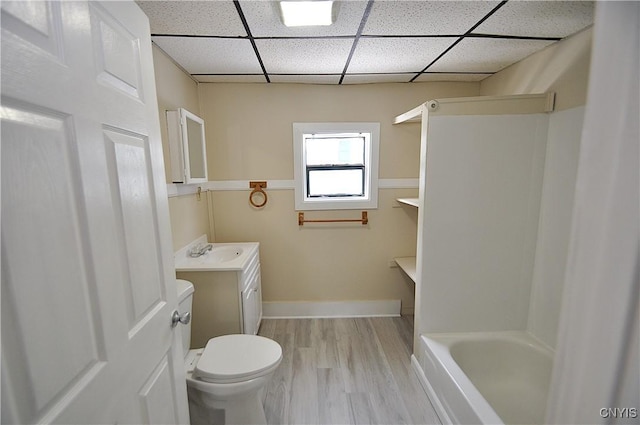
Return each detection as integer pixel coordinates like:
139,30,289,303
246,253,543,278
474,1,594,37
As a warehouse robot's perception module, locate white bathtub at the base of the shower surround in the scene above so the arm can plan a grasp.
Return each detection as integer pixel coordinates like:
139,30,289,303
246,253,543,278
413,332,553,424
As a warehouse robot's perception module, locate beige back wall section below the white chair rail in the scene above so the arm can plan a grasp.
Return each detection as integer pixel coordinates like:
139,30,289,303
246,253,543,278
213,189,417,312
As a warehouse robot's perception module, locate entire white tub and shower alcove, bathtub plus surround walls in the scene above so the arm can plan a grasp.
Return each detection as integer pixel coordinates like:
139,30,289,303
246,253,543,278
406,96,583,423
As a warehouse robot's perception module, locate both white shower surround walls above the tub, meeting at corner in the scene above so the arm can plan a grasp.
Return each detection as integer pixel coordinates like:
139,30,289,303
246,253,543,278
416,98,584,348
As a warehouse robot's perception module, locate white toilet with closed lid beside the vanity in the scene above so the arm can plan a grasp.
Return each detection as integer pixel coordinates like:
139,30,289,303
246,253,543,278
176,279,282,425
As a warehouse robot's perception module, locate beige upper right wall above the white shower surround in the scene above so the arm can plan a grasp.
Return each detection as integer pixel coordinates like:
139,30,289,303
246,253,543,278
480,28,593,111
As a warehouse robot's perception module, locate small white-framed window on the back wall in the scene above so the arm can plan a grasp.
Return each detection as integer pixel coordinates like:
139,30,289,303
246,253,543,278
293,123,380,210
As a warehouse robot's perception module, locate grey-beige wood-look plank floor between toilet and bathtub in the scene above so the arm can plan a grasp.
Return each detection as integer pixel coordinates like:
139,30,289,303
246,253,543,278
259,317,440,425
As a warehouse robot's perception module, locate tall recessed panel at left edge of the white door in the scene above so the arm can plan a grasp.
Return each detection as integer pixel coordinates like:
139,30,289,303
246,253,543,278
1,100,103,416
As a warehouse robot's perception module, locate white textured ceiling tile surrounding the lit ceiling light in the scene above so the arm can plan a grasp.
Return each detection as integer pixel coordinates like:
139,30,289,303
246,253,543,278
240,0,367,37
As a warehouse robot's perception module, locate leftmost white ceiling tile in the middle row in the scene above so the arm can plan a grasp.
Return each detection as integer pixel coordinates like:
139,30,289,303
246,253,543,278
152,37,262,74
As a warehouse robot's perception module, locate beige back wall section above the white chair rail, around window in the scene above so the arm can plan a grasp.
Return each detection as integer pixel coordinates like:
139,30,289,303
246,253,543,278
200,83,479,180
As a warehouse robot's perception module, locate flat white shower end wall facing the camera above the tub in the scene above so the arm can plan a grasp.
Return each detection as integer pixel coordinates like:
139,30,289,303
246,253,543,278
416,102,549,333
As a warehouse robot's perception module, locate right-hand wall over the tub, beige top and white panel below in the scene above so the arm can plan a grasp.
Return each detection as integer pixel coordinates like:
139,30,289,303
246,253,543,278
480,28,593,348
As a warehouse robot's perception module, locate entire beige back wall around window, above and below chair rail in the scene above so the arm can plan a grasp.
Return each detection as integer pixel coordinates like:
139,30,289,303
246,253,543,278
200,83,479,312
